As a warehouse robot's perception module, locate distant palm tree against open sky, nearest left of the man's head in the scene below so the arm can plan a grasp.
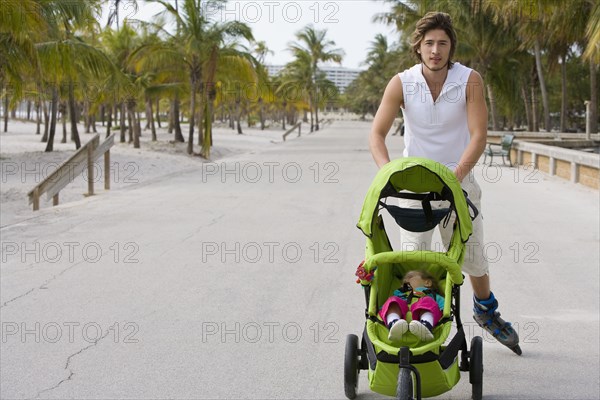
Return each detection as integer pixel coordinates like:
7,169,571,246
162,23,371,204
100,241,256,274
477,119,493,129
289,25,344,132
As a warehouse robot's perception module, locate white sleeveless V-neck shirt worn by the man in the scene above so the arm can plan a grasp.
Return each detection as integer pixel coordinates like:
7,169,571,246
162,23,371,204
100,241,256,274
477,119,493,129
398,63,472,169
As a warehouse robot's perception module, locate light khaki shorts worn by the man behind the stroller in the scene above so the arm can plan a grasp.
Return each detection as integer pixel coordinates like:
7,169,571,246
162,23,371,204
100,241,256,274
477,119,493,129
400,174,489,276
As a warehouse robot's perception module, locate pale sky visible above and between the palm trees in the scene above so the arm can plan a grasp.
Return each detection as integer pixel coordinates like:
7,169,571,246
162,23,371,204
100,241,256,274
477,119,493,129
101,0,399,69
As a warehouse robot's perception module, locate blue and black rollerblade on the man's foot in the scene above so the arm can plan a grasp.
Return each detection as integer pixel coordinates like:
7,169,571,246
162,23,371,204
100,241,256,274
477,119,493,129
473,293,522,355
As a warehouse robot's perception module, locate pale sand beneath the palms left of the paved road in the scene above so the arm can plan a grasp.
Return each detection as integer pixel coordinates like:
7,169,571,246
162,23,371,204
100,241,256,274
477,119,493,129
0,120,297,227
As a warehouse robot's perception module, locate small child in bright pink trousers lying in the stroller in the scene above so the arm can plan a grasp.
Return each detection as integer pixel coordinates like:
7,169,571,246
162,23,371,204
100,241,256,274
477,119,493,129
379,270,444,342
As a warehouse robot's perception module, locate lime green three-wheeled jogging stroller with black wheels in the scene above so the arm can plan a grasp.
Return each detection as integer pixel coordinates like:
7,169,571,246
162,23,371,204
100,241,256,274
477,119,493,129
344,157,483,400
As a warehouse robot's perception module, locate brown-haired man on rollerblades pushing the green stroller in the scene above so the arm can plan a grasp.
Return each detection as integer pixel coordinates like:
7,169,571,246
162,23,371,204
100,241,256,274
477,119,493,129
369,12,521,354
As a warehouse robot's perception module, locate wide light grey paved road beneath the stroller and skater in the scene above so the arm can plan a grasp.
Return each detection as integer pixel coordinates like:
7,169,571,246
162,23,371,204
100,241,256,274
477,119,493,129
0,123,600,399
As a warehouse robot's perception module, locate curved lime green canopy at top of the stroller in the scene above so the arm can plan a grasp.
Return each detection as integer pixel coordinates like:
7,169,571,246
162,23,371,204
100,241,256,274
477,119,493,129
357,157,473,243
